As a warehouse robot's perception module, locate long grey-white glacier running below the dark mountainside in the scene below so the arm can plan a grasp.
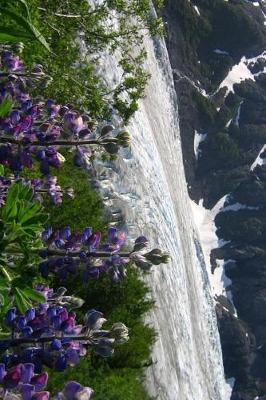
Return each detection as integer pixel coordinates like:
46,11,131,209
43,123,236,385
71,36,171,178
84,4,231,400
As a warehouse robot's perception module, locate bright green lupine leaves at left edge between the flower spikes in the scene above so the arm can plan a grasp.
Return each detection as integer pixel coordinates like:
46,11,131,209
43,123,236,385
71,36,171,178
0,183,47,314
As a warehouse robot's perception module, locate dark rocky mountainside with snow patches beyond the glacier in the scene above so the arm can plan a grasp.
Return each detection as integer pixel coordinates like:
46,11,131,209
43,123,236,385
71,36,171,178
163,0,266,400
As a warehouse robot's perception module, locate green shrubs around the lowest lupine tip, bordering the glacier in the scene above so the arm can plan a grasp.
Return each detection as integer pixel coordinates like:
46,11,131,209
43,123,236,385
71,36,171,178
49,268,155,400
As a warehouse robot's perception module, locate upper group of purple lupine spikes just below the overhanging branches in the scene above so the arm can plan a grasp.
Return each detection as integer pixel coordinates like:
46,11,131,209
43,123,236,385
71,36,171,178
0,51,130,175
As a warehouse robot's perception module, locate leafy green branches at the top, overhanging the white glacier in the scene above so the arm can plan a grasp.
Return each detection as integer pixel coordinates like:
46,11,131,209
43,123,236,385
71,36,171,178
3,0,162,121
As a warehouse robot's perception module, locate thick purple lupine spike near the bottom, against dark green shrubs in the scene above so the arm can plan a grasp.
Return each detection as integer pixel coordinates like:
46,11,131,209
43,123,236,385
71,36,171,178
0,285,128,373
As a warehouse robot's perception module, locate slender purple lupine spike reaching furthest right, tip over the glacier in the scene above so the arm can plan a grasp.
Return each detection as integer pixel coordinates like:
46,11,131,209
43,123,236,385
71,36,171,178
39,227,169,283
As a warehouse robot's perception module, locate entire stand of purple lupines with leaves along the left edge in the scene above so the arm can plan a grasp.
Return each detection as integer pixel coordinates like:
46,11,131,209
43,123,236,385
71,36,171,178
0,37,169,400
